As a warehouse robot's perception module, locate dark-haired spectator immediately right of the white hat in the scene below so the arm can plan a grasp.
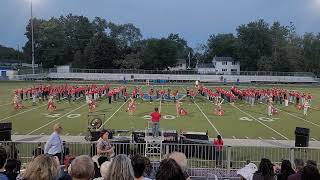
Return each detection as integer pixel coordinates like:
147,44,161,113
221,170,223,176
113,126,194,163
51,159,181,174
252,158,276,180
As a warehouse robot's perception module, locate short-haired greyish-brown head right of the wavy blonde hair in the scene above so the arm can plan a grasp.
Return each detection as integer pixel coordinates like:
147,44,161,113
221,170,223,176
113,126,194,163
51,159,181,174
70,155,94,180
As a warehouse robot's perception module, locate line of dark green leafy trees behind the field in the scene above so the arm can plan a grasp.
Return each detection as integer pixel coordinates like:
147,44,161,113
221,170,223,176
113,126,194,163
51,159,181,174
0,14,320,74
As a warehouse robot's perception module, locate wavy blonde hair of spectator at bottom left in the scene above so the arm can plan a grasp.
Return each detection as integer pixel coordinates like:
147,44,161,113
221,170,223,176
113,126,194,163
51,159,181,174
23,155,59,180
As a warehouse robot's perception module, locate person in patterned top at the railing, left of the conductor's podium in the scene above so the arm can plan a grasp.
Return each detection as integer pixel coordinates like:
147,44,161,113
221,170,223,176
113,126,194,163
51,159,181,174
97,130,114,158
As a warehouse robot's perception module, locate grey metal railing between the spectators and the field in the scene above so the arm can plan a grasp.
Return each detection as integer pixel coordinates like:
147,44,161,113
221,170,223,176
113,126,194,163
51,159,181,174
0,142,320,176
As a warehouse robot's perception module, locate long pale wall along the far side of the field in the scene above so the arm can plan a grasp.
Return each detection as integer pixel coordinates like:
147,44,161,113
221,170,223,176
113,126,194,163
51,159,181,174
48,73,316,83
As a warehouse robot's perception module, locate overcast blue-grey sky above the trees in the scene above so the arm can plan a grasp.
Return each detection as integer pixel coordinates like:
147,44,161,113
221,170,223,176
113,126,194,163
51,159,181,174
0,0,320,48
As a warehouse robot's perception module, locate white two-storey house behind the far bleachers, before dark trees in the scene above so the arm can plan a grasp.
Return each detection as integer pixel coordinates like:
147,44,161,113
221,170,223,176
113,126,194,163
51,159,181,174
197,57,240,75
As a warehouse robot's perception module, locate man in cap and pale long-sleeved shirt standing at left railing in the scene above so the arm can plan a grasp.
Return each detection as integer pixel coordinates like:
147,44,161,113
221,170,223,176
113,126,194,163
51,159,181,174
44,123,63,162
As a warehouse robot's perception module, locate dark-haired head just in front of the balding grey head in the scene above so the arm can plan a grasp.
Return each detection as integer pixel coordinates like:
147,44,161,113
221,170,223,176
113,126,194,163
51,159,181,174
156,159,186,180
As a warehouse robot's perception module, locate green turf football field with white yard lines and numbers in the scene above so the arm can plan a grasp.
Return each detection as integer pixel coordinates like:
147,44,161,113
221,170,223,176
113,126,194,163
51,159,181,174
0,82,320,141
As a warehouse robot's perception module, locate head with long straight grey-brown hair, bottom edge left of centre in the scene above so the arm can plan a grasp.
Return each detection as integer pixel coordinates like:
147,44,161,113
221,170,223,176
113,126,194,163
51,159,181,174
106,154,134,180
